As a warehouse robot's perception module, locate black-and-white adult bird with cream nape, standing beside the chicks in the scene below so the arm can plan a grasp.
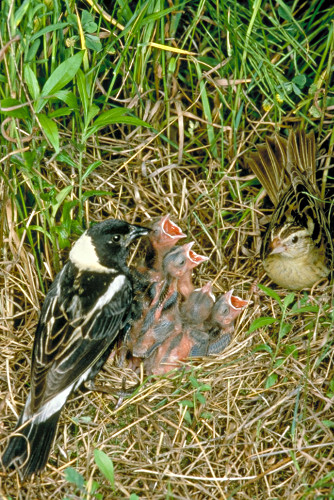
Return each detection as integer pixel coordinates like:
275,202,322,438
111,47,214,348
2,219,150,478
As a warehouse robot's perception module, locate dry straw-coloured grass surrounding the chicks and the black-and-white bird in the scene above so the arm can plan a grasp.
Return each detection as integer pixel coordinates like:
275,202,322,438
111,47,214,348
0,119,334,500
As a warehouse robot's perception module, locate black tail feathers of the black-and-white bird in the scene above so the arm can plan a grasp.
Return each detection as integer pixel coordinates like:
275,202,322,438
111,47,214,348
2,411,60,478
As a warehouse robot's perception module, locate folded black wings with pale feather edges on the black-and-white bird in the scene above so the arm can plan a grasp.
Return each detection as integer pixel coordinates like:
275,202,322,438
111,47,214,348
30,275,132,413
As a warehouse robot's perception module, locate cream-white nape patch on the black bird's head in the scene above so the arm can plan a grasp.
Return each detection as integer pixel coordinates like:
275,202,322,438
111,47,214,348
70,231,115,273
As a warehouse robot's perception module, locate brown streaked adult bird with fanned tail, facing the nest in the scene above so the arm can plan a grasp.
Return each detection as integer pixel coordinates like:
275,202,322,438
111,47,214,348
246,130,334,290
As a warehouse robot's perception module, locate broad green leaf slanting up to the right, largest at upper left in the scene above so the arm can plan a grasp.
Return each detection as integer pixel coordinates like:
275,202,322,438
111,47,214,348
41,51,84,97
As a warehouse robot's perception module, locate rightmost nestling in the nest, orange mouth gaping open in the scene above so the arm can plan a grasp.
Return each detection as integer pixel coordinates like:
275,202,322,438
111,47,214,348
207,290,249,354
